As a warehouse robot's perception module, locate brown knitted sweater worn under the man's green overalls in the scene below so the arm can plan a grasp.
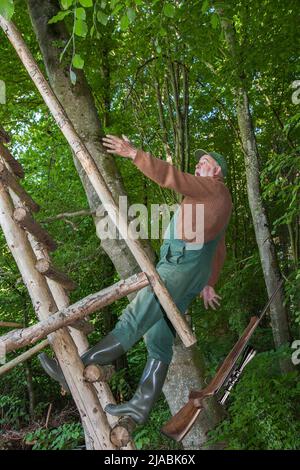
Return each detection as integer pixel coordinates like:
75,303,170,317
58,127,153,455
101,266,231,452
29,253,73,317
133,149,232,286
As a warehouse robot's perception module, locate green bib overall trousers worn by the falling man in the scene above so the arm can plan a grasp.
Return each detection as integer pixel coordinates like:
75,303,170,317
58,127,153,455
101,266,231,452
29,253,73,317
111,213,224,364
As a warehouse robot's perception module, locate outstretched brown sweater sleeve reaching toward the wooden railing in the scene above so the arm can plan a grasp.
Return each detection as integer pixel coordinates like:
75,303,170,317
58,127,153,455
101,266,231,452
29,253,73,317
133,149,216,198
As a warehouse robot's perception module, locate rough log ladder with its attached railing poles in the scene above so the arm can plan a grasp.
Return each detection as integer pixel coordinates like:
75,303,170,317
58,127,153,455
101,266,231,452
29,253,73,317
0,15,196,449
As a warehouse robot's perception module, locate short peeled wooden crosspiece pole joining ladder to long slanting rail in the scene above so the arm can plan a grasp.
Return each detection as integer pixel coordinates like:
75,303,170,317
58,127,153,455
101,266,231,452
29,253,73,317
0,273,148,352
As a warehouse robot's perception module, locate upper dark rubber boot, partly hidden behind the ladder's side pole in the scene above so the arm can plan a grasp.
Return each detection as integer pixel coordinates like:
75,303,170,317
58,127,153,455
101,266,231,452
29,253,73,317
38,333,125,393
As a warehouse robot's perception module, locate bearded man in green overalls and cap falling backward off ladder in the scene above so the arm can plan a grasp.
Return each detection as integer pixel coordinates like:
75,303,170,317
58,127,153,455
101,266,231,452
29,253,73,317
39,135,232,424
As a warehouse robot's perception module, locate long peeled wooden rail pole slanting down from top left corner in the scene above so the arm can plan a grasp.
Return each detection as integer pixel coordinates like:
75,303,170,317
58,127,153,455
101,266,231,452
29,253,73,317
0,15,197,347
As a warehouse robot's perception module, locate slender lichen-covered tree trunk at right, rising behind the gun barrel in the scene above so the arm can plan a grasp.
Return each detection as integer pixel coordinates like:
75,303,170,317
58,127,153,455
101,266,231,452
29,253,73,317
218,9,291,360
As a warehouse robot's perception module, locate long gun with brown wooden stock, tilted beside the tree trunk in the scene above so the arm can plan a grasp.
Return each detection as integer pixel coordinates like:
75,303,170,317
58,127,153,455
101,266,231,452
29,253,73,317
161,279,283,442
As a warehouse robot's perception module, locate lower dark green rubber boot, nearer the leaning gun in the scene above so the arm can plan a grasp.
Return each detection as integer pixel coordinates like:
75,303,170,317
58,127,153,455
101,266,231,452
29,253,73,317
105,357,169,424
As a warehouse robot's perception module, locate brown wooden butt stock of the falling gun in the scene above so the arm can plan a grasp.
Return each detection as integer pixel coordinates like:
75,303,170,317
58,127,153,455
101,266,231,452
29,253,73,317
161,399,203,442
